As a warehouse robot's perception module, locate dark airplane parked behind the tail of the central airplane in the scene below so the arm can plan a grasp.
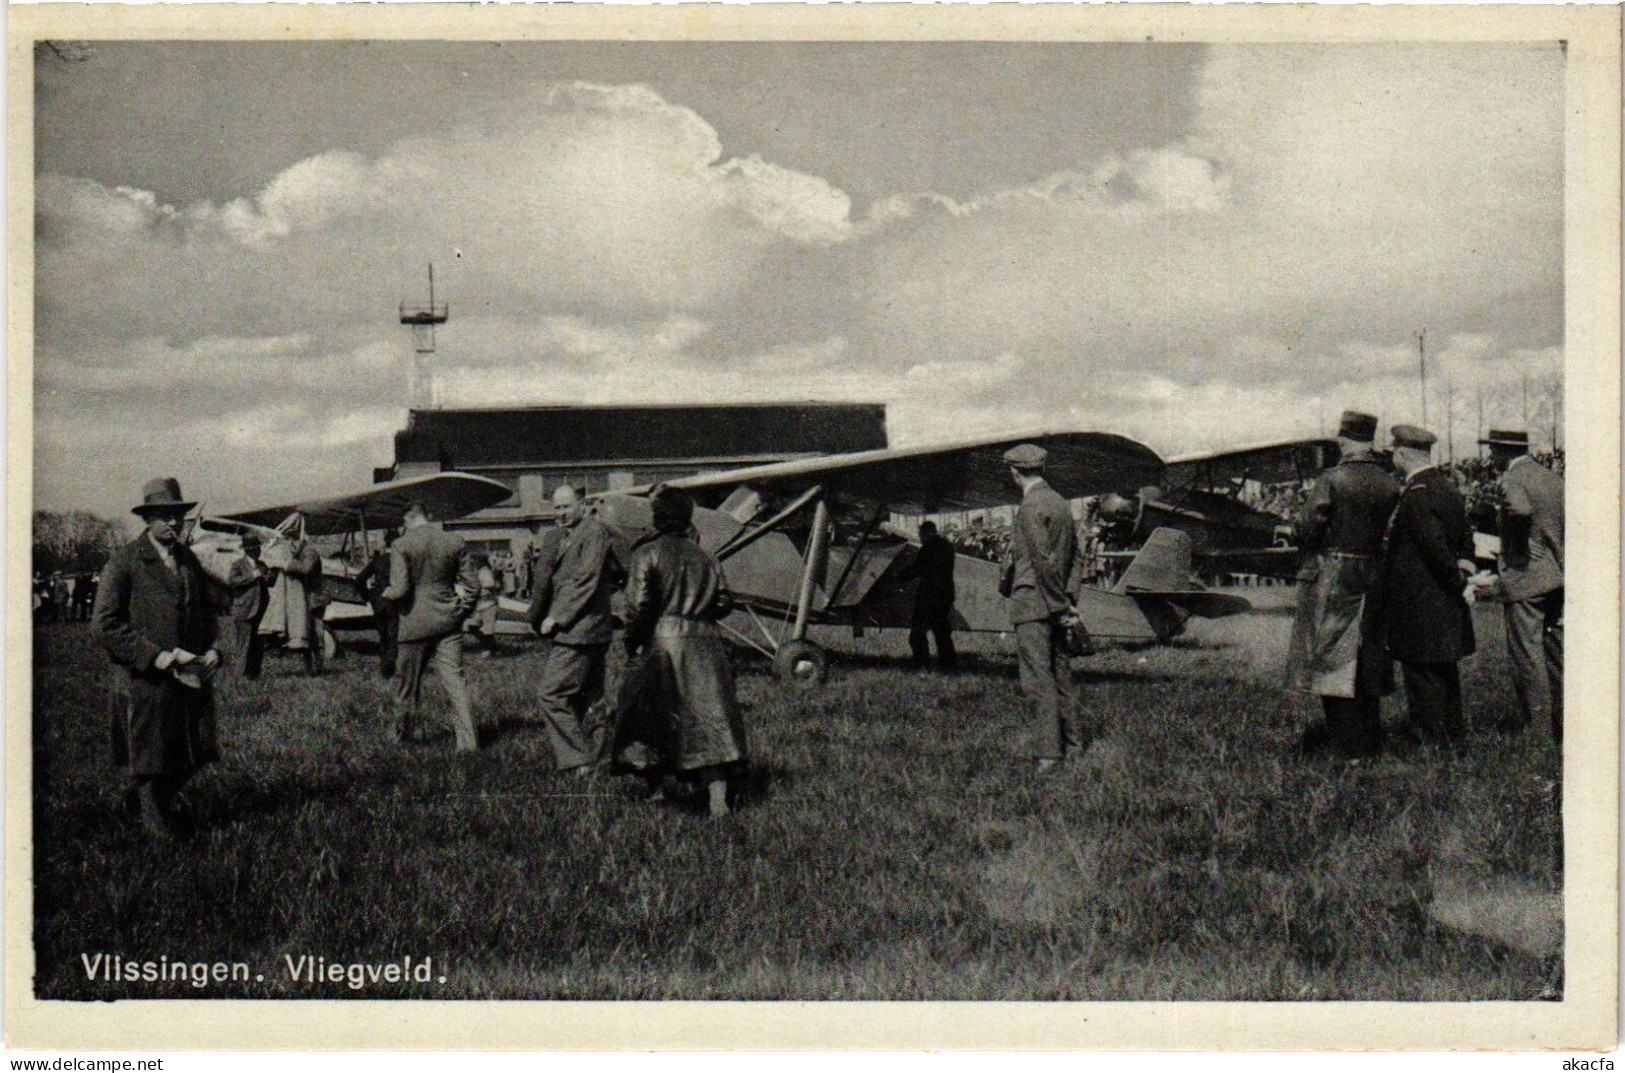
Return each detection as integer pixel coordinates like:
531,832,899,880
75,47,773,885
1100,439,1339,577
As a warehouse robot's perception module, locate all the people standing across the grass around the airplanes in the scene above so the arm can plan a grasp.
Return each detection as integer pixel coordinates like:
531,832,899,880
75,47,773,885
79,422,1563,837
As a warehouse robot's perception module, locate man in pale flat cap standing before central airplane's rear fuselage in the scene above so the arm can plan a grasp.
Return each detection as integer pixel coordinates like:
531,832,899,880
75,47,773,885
999,444,1084,772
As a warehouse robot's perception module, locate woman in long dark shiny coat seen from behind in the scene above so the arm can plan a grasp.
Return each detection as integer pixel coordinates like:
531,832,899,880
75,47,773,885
609,488,748,816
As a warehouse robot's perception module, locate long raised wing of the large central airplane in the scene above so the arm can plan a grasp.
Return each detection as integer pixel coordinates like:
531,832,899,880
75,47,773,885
629,431,1162,514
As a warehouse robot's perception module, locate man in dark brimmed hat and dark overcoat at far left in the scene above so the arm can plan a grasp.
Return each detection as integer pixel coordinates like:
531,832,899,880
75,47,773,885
91,476,219,841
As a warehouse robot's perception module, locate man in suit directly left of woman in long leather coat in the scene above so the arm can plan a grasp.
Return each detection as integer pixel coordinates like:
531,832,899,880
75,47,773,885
530,484,624,777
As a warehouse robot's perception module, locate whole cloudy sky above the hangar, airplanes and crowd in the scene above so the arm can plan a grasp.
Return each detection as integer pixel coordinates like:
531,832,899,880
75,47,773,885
36,42,1563,515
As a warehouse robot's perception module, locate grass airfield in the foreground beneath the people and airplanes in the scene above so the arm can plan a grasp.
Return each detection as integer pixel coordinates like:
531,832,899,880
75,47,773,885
34,598,1562,1000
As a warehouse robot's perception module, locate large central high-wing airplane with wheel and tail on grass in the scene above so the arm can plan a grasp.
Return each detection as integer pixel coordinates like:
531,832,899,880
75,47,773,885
593,431,1250,684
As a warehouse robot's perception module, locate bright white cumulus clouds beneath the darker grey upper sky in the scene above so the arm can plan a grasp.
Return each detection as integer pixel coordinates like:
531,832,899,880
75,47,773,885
36,46,1563,520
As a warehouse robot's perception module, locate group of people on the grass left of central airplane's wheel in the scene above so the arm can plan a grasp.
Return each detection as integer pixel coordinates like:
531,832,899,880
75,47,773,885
91,478,748,839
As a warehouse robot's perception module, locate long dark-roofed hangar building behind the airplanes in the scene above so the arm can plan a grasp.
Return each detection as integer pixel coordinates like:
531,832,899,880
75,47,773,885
374,402,887,551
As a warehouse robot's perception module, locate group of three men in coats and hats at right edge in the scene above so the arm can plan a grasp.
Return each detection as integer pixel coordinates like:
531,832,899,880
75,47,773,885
1287,411,1563,759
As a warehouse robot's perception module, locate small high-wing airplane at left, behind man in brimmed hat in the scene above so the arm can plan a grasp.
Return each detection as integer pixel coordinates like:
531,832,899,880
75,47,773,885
190,473,512,657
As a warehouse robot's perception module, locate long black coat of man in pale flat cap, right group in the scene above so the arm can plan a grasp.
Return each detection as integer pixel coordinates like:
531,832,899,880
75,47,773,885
1383,468,1474,663
